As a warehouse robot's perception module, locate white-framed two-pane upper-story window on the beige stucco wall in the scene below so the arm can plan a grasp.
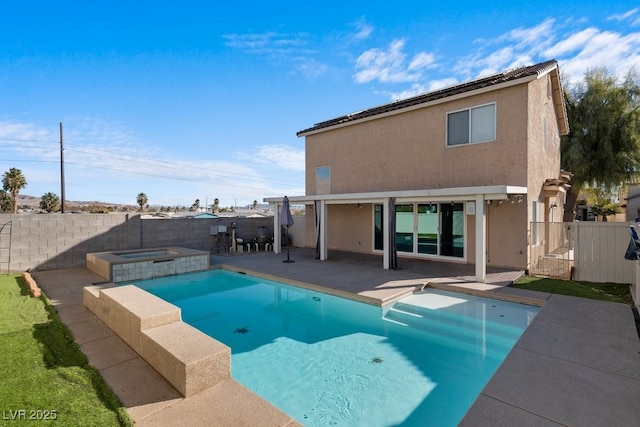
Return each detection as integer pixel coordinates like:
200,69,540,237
447,103,496,146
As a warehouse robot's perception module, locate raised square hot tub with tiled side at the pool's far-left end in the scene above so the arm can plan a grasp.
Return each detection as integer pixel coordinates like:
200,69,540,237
87,247,209,283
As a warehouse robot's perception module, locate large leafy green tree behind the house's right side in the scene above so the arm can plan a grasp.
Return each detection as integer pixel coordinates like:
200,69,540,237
560,68,640,221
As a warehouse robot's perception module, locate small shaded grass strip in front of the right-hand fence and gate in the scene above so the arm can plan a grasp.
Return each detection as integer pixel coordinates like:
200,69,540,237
512,276,631,304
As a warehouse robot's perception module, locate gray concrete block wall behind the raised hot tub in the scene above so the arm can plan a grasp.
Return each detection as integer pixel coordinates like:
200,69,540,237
0,213,273,273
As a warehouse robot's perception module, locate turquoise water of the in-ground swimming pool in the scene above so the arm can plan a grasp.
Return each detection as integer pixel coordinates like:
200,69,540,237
135,270,538,426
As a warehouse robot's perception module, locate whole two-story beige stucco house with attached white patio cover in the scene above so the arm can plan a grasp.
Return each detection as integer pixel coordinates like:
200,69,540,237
265,60,568,281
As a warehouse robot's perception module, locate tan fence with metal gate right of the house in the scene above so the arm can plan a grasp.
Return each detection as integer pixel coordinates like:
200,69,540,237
529,221,635,283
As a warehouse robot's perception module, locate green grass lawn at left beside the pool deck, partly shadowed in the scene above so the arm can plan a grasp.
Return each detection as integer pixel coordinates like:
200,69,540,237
0,275,132,426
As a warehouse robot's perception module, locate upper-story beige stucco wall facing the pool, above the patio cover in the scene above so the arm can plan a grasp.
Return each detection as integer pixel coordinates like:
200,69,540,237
306,86,527,195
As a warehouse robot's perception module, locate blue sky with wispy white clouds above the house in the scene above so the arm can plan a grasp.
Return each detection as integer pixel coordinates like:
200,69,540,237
0,0,640,206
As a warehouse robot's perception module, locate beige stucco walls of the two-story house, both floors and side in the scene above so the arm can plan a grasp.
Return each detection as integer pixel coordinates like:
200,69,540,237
305,72,562,268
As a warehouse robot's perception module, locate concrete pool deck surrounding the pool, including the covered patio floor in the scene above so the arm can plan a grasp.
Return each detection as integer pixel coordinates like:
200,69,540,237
32,248,640,426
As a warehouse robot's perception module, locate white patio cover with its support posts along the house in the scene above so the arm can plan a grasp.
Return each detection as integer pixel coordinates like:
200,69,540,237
264,185,527,282
